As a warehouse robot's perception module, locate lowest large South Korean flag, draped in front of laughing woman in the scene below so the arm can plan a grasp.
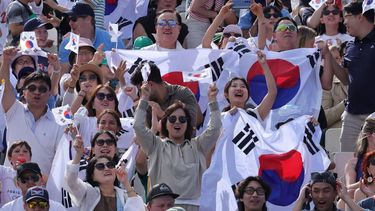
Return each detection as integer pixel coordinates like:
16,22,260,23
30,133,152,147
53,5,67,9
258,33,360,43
200,109,330,211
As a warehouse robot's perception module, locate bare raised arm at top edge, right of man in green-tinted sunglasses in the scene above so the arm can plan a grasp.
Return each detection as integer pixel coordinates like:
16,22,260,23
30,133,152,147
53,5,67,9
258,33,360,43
202,1,233,48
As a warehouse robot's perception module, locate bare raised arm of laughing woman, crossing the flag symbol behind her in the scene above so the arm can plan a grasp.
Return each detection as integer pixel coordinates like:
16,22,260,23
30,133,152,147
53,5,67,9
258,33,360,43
256,51,277,120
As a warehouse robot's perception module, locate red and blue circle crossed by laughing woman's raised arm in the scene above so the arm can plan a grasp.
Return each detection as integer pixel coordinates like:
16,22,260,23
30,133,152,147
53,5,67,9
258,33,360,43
247,59,300,109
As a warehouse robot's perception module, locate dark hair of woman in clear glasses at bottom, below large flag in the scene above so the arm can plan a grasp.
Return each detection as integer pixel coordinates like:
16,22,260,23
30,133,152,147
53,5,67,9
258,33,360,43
236,176,271,211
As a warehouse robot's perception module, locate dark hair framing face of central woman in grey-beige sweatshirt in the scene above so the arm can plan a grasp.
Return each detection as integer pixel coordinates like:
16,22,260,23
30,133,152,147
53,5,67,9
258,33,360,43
160,100,193,140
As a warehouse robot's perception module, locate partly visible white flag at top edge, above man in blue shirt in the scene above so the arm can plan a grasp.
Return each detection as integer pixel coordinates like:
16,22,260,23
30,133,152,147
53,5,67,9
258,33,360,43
104,0,149,39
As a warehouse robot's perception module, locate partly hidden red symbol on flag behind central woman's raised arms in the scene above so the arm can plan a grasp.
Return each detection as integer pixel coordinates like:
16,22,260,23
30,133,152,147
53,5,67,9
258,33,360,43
162,71,200,101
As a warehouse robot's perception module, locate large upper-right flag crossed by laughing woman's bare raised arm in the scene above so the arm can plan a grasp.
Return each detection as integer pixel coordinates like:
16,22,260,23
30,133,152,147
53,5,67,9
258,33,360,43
236,48,322,130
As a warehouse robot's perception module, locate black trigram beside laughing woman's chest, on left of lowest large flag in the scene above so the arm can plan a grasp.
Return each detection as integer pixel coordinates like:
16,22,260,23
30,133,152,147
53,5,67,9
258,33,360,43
232,123,259,155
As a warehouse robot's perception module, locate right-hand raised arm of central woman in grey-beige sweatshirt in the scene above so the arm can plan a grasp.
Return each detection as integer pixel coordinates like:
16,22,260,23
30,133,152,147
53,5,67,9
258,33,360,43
196,84,221,155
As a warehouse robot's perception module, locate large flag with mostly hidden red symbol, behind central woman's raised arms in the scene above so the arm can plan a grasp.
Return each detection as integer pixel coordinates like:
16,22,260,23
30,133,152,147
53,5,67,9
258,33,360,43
106,49,239,119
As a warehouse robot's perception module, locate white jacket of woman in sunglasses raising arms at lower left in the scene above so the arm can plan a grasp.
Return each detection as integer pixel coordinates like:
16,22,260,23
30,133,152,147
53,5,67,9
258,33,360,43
63,162,145,211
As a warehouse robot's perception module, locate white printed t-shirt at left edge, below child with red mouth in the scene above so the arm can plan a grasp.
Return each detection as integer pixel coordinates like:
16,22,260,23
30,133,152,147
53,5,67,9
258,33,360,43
0,166,22,207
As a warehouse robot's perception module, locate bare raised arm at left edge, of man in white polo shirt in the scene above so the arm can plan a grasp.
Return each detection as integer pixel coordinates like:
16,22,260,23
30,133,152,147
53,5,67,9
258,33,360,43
0,47,18,112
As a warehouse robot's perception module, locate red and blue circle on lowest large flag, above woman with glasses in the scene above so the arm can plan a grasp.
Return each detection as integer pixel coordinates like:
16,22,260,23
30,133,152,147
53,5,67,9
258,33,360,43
259,150,305,206
